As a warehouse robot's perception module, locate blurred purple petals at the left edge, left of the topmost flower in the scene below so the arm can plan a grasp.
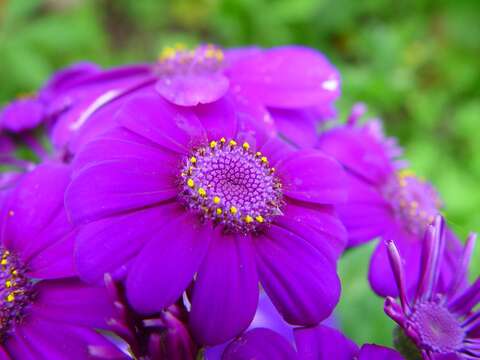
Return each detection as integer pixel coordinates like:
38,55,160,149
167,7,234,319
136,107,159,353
0,63,98,133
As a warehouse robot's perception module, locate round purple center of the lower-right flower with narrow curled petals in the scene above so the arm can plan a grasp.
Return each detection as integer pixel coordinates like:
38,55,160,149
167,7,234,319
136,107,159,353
410,302,465,353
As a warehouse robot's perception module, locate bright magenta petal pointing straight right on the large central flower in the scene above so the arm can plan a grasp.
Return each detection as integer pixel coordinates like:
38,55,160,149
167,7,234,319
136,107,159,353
277,150,347,204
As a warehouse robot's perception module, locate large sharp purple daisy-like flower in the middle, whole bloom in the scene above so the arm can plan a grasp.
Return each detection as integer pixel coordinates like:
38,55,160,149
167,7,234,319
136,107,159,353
66,93,346,345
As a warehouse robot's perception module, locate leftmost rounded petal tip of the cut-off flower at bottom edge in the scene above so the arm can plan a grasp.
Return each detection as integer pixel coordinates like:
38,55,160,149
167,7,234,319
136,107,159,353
222,328,297,360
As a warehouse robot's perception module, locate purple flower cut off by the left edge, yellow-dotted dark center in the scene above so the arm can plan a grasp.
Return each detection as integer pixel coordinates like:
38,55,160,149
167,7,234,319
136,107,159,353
0,164,121,360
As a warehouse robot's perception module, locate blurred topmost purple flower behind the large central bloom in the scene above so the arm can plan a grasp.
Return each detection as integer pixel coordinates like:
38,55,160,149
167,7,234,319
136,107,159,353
53,44,340,154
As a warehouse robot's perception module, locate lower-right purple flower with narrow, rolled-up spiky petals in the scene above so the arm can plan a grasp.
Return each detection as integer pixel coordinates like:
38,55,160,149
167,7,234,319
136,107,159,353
385,216,480,359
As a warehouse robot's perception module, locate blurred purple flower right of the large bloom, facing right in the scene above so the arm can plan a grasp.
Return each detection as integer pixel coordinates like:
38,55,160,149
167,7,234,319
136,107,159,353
318,107,460,296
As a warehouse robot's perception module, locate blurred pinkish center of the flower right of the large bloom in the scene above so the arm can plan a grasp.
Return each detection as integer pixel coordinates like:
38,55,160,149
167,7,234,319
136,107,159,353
383,170,443,236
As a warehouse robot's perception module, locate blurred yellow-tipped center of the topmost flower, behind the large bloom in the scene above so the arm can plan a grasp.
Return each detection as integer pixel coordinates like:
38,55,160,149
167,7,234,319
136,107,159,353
156,44,225,76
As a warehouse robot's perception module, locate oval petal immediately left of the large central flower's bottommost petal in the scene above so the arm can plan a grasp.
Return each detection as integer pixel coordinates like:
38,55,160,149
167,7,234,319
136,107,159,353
127,214,212,313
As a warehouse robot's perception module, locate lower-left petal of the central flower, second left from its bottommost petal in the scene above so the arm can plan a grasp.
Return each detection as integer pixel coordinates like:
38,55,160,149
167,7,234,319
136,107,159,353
75,204,181,284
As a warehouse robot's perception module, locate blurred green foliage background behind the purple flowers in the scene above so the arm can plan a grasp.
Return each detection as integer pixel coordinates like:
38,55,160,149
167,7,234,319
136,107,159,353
0,0,480,345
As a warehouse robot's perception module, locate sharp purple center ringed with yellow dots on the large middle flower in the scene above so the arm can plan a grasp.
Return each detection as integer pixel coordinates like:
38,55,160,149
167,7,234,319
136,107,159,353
180,138,282,234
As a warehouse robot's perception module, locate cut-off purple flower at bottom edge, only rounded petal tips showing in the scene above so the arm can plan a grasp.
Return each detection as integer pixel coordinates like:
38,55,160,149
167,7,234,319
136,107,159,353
222,325,403,360
